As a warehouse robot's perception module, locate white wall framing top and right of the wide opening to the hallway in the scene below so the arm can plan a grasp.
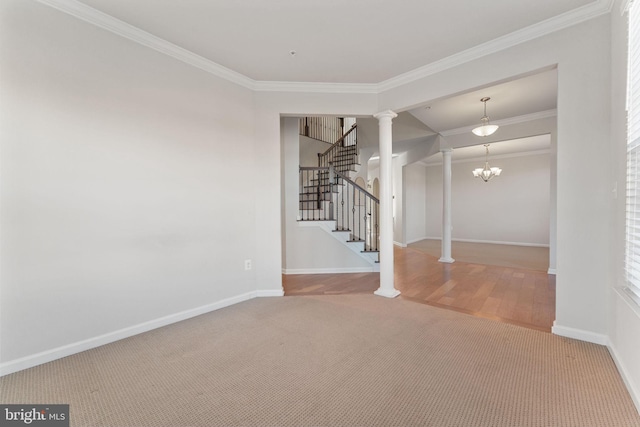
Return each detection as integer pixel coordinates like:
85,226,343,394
379,15,612,342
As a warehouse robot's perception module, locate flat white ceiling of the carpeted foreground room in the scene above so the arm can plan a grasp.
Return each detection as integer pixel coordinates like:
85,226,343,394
75,0,610,84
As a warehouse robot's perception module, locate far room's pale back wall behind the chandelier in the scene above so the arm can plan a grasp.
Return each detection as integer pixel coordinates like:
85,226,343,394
425,150,550,246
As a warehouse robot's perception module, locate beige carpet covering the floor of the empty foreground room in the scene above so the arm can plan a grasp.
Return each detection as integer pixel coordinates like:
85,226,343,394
0,295,640,427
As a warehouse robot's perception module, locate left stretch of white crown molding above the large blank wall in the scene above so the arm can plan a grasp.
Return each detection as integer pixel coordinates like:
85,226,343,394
37,0,256,89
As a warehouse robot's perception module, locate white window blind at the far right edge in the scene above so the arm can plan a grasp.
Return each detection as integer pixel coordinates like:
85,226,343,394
625,0,640,301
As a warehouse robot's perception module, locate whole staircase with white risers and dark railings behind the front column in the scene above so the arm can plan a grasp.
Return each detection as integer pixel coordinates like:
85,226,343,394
298,125,380,271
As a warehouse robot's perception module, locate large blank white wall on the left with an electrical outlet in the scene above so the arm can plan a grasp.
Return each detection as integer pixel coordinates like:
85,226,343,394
0,0,261,370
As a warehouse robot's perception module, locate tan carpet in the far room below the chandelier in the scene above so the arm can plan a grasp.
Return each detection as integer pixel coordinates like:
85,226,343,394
408,239,549,271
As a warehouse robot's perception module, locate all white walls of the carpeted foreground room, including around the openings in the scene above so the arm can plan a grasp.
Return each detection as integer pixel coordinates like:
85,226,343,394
0,0,640,412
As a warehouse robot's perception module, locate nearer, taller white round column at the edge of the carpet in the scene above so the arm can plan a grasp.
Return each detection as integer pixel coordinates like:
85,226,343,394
374,110,400,298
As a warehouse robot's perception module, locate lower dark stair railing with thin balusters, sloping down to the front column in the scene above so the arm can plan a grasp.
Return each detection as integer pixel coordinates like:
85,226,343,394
299,165,380,252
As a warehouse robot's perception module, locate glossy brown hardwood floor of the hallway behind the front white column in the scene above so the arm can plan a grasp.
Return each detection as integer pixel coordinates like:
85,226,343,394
283,247,556,332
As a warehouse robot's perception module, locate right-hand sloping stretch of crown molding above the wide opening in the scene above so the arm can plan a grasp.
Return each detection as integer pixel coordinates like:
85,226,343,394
378,0,614,92
